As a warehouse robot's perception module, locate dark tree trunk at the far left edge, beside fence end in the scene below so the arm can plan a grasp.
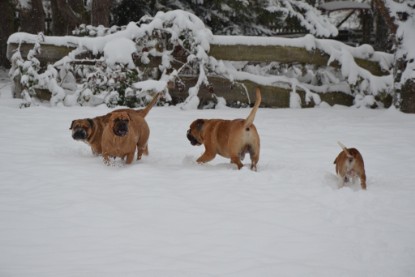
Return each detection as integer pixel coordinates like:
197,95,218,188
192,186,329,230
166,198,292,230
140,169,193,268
0,0,16,67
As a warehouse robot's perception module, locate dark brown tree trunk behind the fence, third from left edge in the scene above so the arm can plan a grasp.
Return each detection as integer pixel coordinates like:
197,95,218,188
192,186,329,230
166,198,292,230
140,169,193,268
51,0,87,36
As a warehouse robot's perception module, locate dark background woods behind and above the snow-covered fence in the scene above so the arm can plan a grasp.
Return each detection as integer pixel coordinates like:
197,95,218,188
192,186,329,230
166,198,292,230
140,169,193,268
0,0,331,66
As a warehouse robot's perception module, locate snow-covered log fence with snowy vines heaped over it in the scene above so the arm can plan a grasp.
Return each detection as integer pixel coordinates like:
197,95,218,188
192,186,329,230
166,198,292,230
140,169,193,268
8,11,393,107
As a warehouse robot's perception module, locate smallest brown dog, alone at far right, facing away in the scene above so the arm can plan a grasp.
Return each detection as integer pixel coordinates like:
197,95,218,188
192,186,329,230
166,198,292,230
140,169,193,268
334,142,366,190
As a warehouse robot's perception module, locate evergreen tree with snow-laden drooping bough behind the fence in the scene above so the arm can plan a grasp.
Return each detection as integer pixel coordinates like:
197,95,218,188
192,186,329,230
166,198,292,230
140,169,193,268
112,0,337,37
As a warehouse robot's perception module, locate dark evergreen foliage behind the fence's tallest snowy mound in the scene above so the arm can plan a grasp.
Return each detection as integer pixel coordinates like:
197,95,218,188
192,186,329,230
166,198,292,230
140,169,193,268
112,0,305,35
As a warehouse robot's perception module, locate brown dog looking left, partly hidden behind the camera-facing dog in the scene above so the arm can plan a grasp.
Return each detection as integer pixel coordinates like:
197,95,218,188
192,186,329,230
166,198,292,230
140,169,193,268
69,93,161,155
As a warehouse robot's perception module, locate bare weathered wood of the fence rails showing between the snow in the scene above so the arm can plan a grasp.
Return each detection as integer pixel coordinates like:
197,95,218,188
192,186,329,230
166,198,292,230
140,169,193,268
7,35,391,110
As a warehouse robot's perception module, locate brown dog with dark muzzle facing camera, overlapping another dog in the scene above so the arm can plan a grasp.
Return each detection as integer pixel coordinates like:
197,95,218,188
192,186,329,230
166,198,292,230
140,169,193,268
101,111,150,165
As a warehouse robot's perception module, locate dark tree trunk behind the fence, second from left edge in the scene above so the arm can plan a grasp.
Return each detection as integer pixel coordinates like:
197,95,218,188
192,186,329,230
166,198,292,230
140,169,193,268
19,0,45,34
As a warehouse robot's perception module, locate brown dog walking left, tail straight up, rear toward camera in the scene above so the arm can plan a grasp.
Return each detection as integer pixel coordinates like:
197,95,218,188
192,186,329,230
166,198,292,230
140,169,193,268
187,88,261,171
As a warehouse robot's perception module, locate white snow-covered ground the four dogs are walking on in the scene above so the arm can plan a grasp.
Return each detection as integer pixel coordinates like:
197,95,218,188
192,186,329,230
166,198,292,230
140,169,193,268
0,67,415,277
